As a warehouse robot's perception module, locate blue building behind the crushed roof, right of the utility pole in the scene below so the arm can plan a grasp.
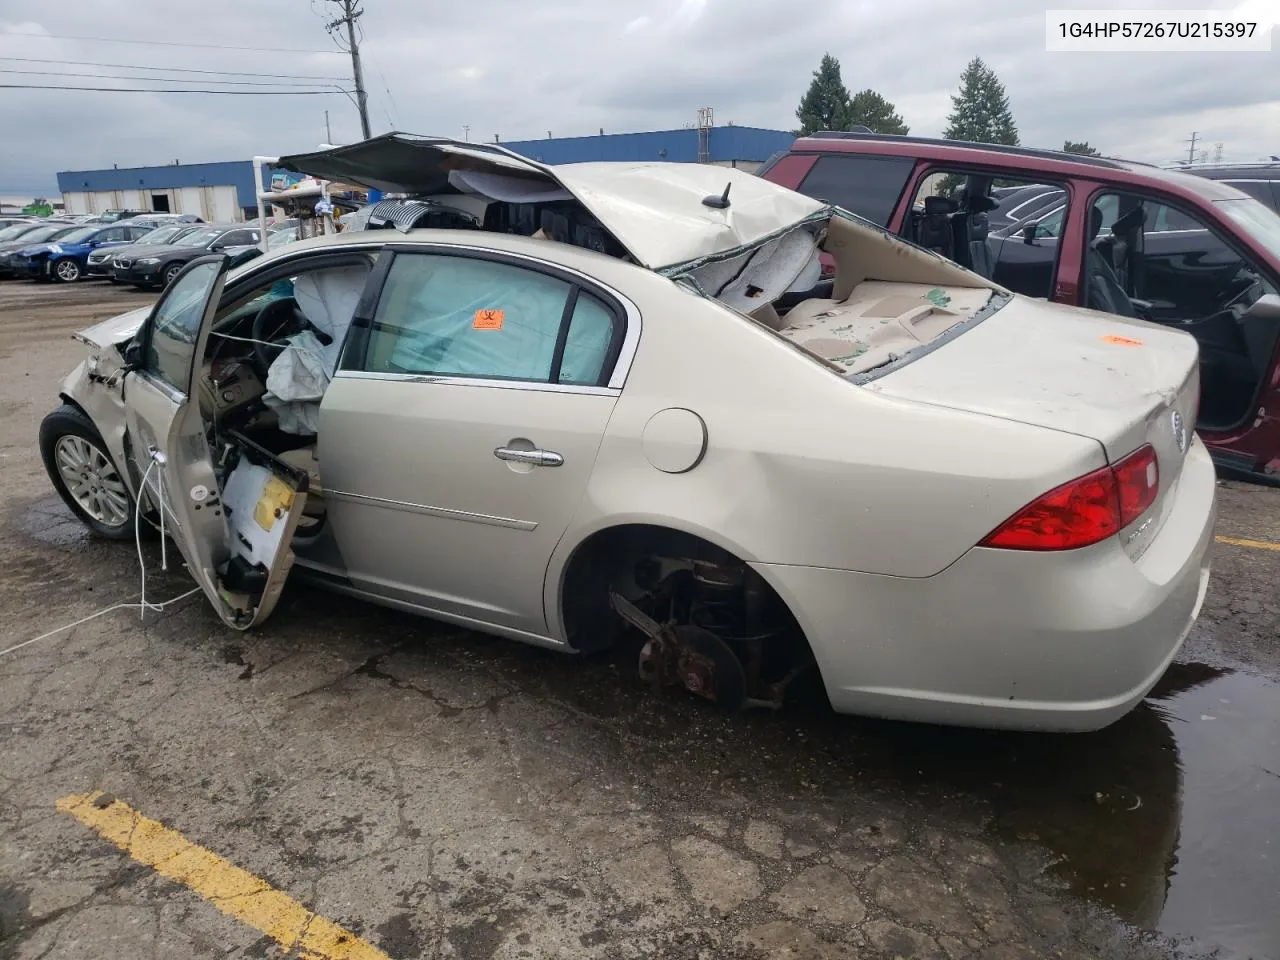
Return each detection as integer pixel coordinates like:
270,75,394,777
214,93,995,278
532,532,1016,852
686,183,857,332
503,127,795,172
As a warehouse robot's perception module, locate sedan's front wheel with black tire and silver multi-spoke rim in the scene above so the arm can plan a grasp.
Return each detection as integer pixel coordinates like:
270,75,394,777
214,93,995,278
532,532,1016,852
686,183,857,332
40,403,136,540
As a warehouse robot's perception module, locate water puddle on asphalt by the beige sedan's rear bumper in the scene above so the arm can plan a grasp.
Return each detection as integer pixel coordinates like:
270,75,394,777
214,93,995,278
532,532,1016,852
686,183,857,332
788,664,1280,960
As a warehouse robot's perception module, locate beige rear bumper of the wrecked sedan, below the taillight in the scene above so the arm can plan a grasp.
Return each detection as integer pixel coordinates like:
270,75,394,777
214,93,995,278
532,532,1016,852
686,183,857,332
755,440,1216,731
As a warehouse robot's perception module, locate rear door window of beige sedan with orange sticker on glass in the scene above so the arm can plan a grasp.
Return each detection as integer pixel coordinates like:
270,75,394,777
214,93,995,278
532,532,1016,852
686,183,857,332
364,253,621,385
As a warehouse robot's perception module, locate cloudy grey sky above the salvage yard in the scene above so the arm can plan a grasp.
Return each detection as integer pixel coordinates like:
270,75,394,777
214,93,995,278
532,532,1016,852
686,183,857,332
0,0,1280,195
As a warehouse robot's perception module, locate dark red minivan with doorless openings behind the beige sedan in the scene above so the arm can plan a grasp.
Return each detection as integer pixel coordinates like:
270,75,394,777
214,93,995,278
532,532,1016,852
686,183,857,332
759,133,1280,485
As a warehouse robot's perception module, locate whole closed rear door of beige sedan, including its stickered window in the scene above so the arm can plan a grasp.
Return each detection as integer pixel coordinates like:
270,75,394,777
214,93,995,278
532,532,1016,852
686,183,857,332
319,246,624,643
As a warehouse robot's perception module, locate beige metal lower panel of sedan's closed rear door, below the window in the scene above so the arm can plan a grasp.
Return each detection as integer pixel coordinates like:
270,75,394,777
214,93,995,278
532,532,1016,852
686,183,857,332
320,374,616,636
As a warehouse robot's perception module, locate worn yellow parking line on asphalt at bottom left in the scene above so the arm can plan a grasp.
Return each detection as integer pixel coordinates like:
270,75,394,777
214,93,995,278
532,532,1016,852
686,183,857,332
58,792,389,960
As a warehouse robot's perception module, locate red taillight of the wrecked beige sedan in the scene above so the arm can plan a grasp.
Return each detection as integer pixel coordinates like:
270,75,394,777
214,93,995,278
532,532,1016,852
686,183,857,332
979,445,1160,550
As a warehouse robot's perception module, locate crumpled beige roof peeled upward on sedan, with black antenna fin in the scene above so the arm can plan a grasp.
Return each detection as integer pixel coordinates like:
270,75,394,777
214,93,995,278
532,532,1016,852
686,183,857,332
276,133,828,270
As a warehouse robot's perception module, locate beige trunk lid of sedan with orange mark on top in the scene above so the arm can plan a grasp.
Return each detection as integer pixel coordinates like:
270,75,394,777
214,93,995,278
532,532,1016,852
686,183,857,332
865,297,1199,548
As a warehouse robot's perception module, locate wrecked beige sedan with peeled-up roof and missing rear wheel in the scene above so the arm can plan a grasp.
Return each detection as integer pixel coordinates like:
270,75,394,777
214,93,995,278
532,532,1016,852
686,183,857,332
41,134,1215,731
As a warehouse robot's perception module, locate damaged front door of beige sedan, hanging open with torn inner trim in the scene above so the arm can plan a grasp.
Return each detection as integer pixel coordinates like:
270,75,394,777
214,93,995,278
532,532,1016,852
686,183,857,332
124,255,307,630
